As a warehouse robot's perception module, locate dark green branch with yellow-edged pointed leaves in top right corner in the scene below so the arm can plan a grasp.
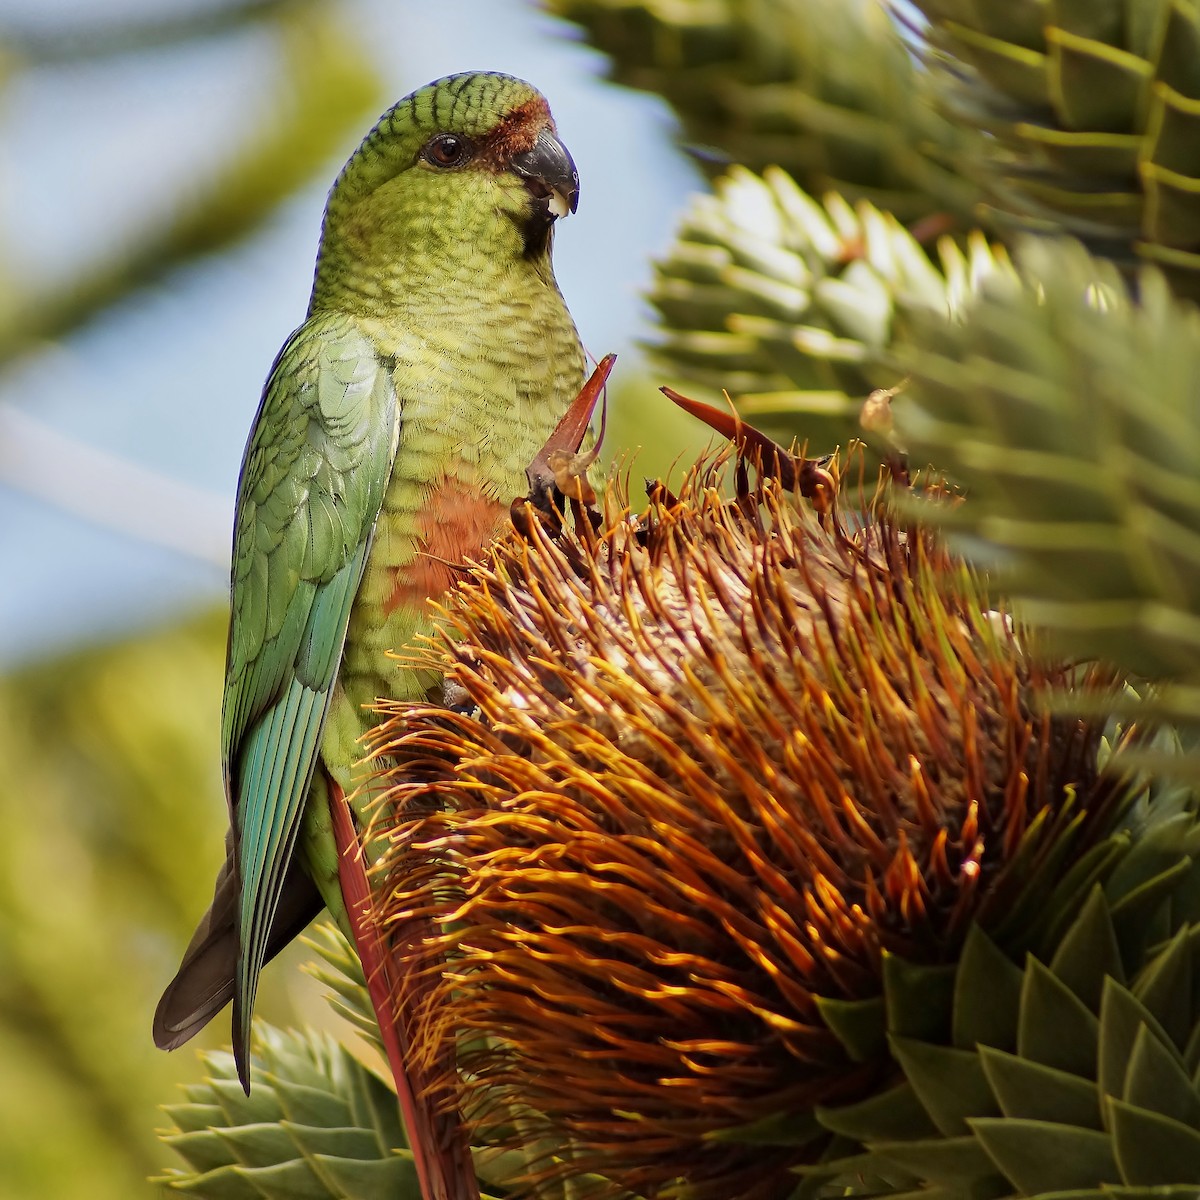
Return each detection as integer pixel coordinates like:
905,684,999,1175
917,0,1200,298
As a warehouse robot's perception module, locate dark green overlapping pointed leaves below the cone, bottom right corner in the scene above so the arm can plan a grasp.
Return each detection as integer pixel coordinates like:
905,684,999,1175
809,868,1200,1200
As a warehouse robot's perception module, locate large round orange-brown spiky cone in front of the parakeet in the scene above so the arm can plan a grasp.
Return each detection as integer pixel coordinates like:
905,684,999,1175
377,458,1105,1196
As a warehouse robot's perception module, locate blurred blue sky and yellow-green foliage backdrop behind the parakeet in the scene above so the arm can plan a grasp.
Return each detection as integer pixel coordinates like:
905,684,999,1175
0,0,706,1200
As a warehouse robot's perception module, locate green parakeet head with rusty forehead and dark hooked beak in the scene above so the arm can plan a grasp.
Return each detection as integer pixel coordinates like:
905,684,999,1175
313,72,580,305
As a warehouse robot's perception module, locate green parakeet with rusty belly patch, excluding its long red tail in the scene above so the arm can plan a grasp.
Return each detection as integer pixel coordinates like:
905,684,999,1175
154,74,583,1090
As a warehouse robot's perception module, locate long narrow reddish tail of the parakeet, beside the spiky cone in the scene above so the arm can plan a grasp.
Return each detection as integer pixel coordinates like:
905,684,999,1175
329,779,479,1200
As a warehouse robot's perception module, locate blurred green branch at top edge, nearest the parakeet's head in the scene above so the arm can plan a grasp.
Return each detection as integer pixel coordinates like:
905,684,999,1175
550,0,978,221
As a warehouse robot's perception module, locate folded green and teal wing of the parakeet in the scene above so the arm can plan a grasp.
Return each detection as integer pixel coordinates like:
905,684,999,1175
221,316,400,1062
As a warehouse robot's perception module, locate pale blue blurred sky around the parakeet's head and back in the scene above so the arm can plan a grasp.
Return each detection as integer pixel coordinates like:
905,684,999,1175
0,0,700,668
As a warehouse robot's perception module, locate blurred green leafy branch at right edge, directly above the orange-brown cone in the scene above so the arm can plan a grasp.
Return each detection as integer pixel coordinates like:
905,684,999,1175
893,240,1200,753
